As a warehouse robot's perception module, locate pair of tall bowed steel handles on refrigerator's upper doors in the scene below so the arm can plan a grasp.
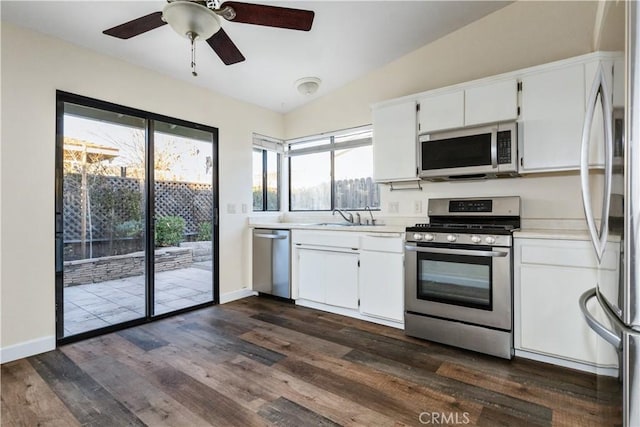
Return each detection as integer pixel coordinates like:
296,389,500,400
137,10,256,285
580,65,613,261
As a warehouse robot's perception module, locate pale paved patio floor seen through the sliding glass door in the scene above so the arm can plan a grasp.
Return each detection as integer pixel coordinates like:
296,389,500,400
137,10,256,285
63,261,213,337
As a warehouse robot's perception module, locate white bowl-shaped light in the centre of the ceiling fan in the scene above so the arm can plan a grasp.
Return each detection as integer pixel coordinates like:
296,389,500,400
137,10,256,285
162,0,220,40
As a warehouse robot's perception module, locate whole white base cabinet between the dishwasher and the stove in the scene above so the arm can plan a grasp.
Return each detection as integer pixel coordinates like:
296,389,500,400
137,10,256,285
292,230,404,328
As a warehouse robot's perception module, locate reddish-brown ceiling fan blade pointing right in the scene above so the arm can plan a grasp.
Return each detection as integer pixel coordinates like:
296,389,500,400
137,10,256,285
220,1,315,31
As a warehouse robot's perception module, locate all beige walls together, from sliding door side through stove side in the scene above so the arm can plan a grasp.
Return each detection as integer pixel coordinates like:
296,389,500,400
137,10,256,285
0,1,619,358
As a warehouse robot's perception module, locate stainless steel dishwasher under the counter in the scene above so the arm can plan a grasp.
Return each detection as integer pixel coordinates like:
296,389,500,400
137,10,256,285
253,228,291,299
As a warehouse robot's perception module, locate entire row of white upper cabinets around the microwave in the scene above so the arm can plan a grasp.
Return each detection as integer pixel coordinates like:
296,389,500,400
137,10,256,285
373,52,624,182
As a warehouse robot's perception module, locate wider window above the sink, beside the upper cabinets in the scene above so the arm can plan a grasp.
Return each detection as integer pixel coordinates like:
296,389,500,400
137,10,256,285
287,126,380,211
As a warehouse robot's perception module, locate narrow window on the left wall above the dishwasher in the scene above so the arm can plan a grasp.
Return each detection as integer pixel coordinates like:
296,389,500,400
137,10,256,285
253,135,282,211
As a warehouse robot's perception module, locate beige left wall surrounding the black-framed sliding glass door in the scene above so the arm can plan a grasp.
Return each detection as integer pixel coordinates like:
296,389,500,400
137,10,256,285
0,23,283,348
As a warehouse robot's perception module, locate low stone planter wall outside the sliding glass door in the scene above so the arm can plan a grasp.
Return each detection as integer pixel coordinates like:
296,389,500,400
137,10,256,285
64,247,193,287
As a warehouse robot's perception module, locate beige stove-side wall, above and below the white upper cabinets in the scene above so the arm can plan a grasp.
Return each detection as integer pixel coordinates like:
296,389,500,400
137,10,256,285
285,1,624,226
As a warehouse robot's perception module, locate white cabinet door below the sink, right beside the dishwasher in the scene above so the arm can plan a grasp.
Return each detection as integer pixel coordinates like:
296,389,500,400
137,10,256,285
298,249,358,309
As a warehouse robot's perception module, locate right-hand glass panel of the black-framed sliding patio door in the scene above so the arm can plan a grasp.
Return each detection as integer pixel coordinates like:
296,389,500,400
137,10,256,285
153,121,214,314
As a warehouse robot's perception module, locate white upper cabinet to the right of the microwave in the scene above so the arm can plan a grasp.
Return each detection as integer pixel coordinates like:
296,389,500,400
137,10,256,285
520,55,624,173
